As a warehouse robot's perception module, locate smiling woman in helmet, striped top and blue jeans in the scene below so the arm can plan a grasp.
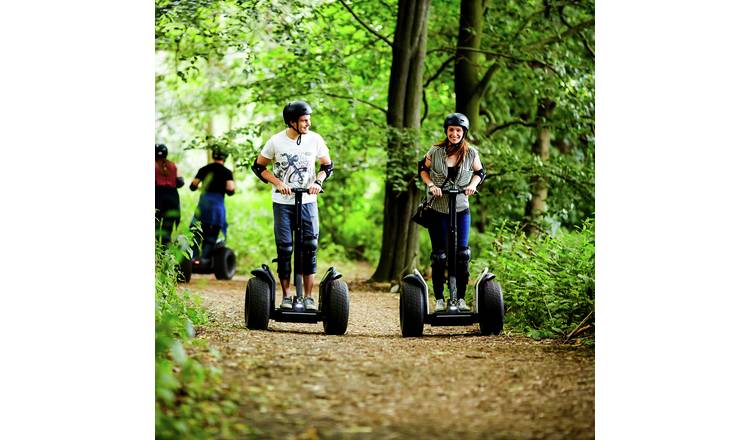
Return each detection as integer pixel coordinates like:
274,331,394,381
419,113,485,312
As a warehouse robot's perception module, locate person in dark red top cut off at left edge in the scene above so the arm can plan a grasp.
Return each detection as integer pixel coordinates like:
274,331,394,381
155,144,185,246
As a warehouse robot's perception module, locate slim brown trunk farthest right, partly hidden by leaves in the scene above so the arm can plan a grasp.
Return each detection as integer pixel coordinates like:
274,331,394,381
524,99,555,237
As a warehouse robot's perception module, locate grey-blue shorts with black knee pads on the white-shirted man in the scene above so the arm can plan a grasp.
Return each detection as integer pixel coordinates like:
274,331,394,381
273,202,320,280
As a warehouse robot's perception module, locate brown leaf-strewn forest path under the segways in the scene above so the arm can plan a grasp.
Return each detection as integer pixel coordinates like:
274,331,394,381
183,265,594,439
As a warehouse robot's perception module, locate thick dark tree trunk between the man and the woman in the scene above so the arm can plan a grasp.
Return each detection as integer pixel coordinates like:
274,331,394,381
372,0,430,281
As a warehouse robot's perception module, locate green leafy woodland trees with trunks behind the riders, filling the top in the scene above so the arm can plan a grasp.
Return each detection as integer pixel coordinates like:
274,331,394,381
155,0,594,280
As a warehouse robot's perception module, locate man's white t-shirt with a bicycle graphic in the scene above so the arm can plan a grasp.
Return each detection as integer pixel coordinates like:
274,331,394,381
260,130,328,205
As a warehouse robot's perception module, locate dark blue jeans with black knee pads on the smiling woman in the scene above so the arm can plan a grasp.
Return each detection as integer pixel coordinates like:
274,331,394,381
429,209,471,299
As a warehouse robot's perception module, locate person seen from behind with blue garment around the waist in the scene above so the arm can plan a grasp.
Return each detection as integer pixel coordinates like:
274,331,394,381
190,150,235,265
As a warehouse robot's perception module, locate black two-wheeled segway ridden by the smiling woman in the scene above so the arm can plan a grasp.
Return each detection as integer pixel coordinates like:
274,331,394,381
399,185,505,337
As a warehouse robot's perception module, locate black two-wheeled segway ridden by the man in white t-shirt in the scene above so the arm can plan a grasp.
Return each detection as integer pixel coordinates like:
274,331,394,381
245,188,349,335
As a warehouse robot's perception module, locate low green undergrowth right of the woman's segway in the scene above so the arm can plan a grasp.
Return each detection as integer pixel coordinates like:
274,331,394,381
482,220,595,338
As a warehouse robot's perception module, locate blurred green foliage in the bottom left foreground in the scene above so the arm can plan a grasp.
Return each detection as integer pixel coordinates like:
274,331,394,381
155,246,248,439
